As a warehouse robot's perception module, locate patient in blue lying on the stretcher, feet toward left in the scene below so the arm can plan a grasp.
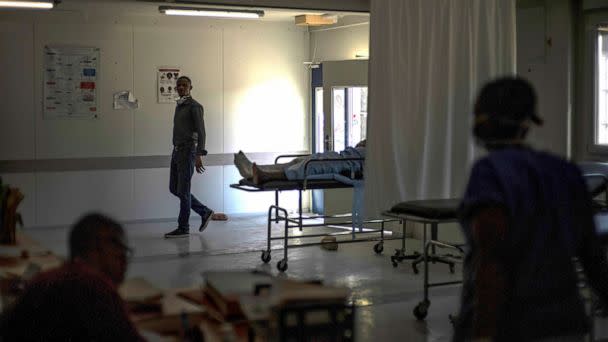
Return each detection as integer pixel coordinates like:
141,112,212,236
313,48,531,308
234,140,365,184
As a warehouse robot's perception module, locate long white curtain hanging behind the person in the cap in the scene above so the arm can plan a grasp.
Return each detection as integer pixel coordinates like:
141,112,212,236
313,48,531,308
365,0,516,217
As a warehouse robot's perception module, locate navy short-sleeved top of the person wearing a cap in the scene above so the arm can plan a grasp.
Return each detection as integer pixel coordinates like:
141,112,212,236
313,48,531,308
454,148,608,341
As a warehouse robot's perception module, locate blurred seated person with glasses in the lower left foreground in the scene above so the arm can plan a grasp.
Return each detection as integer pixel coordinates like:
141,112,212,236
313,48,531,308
0,213,143,341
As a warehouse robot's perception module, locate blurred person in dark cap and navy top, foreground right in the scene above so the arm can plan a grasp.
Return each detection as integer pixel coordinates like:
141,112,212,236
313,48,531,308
454,77,608,341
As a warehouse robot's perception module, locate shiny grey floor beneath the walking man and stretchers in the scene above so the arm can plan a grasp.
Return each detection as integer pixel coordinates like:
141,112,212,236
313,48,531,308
28,216,470,341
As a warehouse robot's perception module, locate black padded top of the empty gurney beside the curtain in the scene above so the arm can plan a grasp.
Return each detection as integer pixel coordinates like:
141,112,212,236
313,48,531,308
390,199,461,219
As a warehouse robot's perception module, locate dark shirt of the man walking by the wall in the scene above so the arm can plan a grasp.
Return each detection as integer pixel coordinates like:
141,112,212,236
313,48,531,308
173,97,207,156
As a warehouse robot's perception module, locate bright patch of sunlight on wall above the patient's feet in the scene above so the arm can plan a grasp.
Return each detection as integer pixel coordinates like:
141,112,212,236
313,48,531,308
230,78,308,152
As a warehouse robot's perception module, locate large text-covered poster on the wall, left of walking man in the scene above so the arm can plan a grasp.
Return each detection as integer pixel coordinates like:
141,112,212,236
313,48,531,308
43,46,100,118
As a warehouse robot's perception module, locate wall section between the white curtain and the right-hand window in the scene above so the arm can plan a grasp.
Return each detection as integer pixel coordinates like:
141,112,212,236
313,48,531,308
517,0,575,157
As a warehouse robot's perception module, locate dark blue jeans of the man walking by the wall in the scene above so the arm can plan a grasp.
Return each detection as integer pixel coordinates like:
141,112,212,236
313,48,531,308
169,145,211,230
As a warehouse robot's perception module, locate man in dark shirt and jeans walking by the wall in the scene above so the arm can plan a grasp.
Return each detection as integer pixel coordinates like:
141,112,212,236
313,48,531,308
165,76,213,238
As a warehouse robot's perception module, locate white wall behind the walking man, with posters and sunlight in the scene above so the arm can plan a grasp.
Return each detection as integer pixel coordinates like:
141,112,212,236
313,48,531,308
0,2,309,226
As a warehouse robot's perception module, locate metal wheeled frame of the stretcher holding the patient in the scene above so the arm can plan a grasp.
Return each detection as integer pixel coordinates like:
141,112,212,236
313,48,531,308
230,154,399,272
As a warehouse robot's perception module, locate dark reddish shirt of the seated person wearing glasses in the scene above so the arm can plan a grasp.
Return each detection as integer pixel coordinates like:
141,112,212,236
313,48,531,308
0,262,143,342
